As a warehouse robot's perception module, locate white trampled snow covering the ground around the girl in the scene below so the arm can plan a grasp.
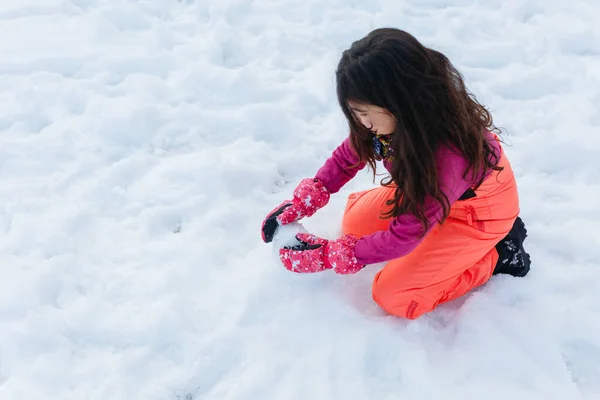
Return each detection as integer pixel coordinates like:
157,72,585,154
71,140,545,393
0,0,600,400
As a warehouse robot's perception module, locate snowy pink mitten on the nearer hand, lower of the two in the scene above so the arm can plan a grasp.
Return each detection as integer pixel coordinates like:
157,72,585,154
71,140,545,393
279,233,365,274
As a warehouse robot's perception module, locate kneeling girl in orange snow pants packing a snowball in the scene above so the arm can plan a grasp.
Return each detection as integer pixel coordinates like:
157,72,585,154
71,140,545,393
262,29,530,319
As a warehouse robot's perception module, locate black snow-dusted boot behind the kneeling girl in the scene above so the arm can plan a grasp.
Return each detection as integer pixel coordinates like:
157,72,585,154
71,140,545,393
493,217,531,277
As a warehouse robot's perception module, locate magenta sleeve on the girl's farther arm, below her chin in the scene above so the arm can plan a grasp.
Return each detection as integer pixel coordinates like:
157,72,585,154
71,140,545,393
315,137,366,193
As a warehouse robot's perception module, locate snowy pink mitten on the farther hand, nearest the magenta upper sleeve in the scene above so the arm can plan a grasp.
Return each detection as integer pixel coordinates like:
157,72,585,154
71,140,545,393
261,178,331,243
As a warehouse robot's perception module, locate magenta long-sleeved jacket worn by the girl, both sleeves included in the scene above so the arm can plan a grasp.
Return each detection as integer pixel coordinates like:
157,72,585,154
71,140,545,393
315,132,500,264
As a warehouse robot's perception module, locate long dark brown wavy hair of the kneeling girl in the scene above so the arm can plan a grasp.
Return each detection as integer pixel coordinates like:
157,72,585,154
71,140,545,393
336,28,502,234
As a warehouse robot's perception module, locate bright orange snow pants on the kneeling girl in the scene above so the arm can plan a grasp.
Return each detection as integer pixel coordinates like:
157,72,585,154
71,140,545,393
342,149,519,319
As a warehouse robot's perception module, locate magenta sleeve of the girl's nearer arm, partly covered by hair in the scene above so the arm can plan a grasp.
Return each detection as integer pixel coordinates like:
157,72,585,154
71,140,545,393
355,148,486,264
